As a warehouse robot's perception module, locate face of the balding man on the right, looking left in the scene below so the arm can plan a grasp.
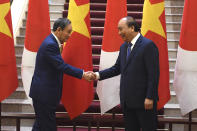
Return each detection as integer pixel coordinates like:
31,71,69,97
118,19,133,42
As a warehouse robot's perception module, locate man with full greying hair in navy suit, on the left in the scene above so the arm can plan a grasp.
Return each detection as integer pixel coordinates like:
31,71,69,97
29,18,94,131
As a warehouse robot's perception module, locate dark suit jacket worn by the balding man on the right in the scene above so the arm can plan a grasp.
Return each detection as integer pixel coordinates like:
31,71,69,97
99,35,159,108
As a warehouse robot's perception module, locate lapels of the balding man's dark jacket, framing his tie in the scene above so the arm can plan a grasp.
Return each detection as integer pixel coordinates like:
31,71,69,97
124,35,143,70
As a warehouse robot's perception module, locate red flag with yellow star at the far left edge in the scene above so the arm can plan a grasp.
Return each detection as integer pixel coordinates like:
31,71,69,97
0,0,18,102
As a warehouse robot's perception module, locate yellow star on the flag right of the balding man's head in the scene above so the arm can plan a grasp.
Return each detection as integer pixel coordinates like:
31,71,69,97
141,0,166,38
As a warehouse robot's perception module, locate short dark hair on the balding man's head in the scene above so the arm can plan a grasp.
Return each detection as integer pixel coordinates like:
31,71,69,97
125,16,140,32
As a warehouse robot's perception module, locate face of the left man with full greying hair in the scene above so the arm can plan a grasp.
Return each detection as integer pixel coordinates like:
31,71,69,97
59,24,72,43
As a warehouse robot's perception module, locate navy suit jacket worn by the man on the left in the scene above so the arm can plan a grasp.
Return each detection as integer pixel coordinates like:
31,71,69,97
29,34,83,106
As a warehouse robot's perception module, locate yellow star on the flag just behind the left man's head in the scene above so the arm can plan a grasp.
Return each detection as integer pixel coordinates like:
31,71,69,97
68,0,90,38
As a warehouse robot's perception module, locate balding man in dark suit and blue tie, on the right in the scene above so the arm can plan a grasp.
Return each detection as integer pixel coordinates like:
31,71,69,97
96,17,159,131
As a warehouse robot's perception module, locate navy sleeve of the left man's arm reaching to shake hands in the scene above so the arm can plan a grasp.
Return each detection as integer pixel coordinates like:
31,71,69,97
45,44,83,79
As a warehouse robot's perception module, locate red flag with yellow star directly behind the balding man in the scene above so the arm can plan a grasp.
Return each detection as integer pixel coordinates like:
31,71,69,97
141,0,170,109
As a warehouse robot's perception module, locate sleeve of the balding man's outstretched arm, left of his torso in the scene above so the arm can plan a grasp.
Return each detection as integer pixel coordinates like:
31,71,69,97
99,53,120,80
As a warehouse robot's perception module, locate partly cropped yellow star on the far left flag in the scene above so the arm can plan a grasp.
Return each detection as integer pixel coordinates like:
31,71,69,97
0,2,12,37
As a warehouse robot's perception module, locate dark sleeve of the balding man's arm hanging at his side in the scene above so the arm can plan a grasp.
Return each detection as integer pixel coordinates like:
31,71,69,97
144,42,159,99
